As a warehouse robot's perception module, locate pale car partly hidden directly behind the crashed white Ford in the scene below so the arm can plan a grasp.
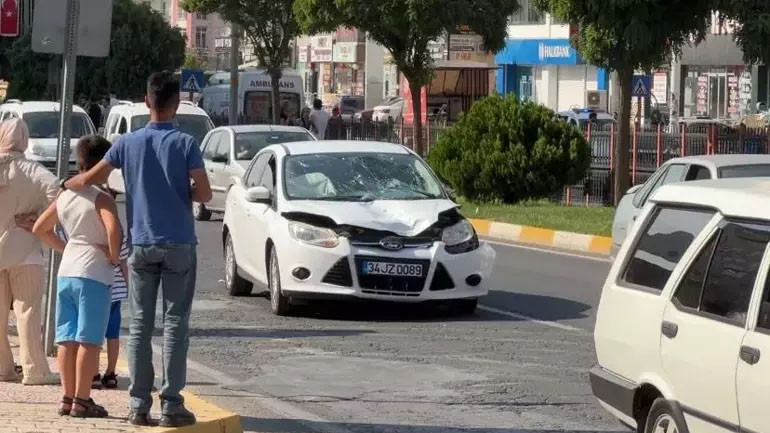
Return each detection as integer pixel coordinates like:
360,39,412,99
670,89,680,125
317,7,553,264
193,125,315,221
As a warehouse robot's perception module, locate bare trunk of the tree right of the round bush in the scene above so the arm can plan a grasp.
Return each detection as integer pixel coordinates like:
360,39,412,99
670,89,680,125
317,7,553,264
613,67,634,206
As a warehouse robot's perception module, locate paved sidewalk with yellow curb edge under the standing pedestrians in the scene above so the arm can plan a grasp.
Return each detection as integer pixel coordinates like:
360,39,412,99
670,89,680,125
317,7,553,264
0,336,242,433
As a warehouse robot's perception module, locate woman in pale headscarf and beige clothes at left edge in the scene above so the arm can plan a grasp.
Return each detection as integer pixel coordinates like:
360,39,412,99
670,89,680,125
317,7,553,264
0,119,59,385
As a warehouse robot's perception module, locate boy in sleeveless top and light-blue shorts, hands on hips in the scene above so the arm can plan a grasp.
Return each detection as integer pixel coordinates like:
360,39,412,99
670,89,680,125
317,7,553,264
33,135,123,418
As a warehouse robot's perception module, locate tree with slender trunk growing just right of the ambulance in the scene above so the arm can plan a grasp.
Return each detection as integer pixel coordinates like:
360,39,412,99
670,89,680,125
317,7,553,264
182,0,299,124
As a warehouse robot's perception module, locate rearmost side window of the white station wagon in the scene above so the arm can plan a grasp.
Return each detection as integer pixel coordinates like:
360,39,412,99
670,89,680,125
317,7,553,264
622,207,714,292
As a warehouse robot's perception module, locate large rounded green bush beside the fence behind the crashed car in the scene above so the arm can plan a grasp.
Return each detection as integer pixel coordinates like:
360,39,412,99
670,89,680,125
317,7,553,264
428,95,590,203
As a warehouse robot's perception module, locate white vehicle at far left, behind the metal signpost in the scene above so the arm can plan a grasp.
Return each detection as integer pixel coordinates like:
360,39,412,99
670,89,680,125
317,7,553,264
0,99,96,173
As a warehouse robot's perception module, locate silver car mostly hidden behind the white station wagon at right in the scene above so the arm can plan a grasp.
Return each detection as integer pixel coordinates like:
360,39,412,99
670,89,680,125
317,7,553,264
612,155,770,256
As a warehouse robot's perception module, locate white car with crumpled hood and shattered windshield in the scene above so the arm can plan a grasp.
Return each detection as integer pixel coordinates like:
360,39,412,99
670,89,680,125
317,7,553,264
222,141,495,315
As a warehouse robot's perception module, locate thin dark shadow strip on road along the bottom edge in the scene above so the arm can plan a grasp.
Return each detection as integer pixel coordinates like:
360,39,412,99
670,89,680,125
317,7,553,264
241,416,627,433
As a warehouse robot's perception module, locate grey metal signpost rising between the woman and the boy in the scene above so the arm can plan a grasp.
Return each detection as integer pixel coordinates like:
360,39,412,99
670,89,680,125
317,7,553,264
45,0,80,356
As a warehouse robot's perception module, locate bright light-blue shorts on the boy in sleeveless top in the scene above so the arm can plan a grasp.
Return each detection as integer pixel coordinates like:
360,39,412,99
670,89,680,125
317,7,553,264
56,277,112,346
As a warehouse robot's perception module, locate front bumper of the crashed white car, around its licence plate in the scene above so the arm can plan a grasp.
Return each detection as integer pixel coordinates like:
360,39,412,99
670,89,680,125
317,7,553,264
277,239,495,302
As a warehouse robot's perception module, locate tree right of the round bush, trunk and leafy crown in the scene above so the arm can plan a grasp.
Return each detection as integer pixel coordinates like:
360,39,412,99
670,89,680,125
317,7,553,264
535,0,714,204
